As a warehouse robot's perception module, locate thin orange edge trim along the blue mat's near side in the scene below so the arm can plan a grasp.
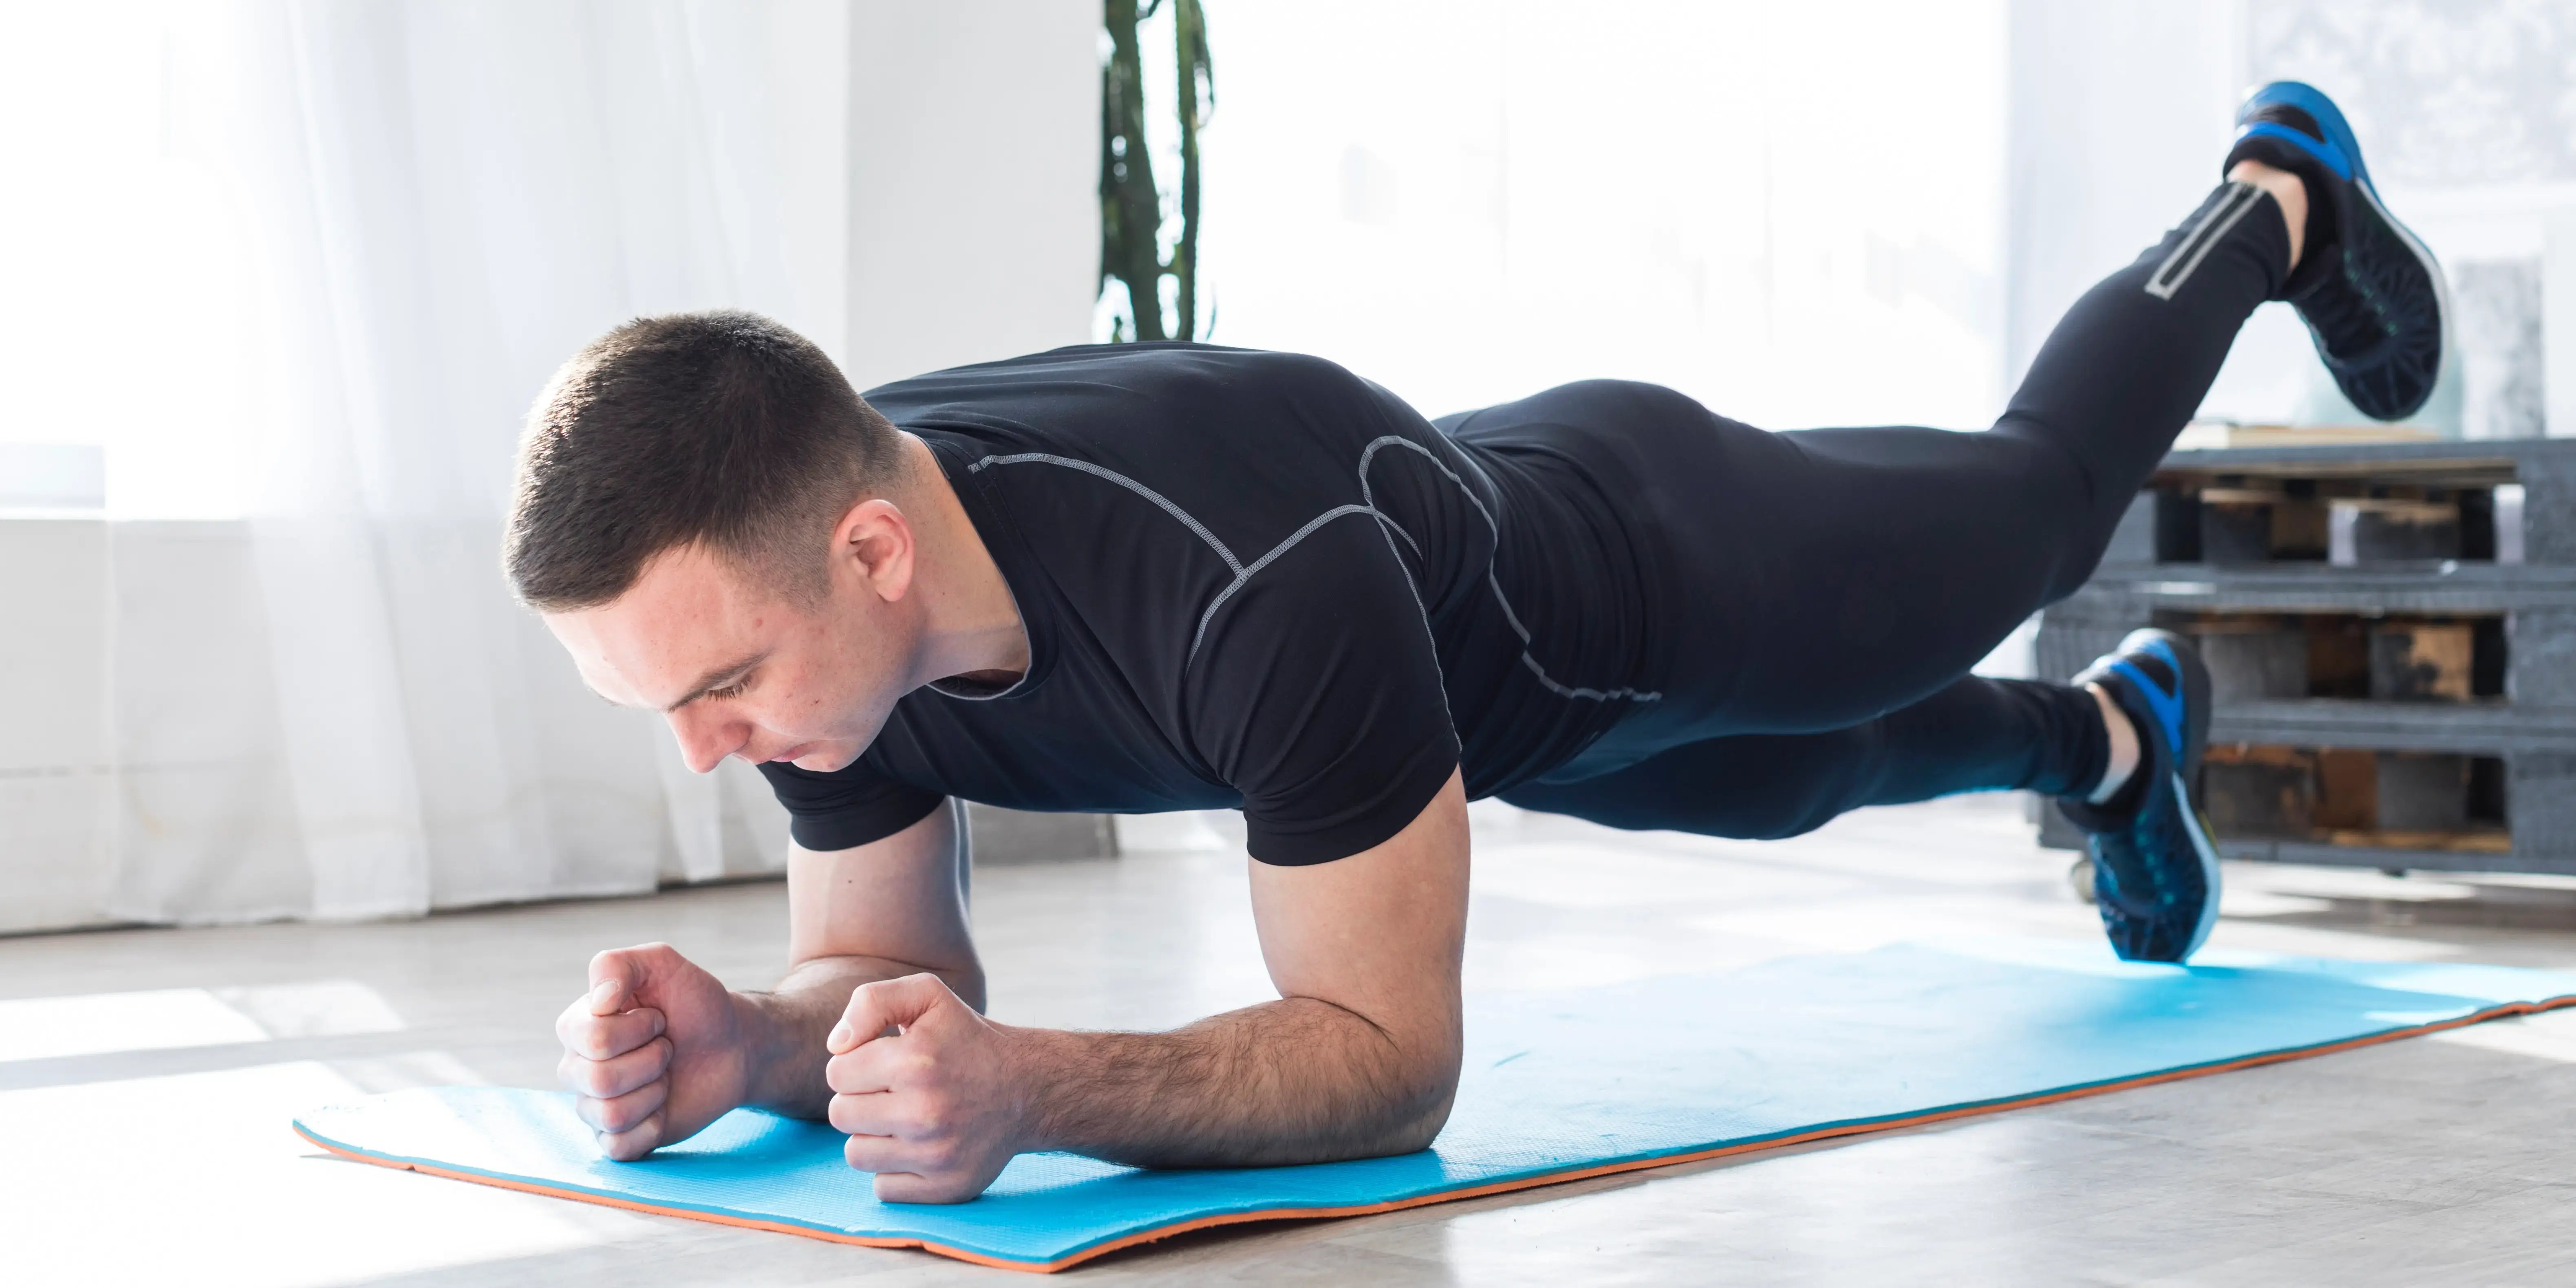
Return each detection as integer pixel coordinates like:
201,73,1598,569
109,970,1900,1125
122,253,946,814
296,995,2576,1275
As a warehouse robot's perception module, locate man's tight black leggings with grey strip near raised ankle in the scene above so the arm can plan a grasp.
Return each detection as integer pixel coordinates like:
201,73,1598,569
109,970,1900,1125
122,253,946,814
1484,183,2290,837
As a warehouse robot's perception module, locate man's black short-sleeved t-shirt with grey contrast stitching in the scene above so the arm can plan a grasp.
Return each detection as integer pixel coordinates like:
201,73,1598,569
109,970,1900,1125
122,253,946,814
760,345,1659,863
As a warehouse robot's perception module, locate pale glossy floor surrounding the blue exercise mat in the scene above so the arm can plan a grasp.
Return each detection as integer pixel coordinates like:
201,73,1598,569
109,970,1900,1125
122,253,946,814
0,798,2576,1288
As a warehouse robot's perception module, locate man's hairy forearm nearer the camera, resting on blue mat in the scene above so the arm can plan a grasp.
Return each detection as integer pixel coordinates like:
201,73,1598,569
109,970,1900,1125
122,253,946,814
1017,997,1458,1167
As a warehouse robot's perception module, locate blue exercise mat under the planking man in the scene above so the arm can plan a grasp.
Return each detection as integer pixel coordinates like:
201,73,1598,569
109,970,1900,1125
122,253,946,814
296,940,2576,1270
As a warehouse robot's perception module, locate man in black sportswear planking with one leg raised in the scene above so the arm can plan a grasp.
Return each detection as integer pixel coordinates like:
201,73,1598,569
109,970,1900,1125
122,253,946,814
507,82,2442,1200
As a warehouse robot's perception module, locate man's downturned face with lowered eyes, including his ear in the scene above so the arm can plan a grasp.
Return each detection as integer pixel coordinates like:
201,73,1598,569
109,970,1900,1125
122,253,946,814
546,536,920,773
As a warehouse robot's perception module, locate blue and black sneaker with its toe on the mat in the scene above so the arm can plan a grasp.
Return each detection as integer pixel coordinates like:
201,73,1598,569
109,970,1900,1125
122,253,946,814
2058,631,2218,961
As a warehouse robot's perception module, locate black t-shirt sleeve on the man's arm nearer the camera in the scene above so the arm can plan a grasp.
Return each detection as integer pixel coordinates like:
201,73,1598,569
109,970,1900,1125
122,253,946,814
1185,510,1458,866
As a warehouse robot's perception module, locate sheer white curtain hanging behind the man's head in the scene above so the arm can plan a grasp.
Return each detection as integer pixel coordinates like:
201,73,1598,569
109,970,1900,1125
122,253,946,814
108,0,847,922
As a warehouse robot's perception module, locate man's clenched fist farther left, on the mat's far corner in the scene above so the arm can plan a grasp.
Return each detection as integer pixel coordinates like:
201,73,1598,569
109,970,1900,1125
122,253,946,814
554,943,750,1162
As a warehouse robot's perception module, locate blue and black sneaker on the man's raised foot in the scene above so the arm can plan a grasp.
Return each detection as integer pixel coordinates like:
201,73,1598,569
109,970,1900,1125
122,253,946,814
2221,80,2450,420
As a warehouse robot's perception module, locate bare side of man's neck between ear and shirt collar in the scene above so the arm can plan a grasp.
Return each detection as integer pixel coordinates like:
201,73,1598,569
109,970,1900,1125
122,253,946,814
902,433,1028,685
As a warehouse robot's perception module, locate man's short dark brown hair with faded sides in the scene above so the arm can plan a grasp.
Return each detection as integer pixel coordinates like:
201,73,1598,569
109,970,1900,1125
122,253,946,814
502,312,902,611
